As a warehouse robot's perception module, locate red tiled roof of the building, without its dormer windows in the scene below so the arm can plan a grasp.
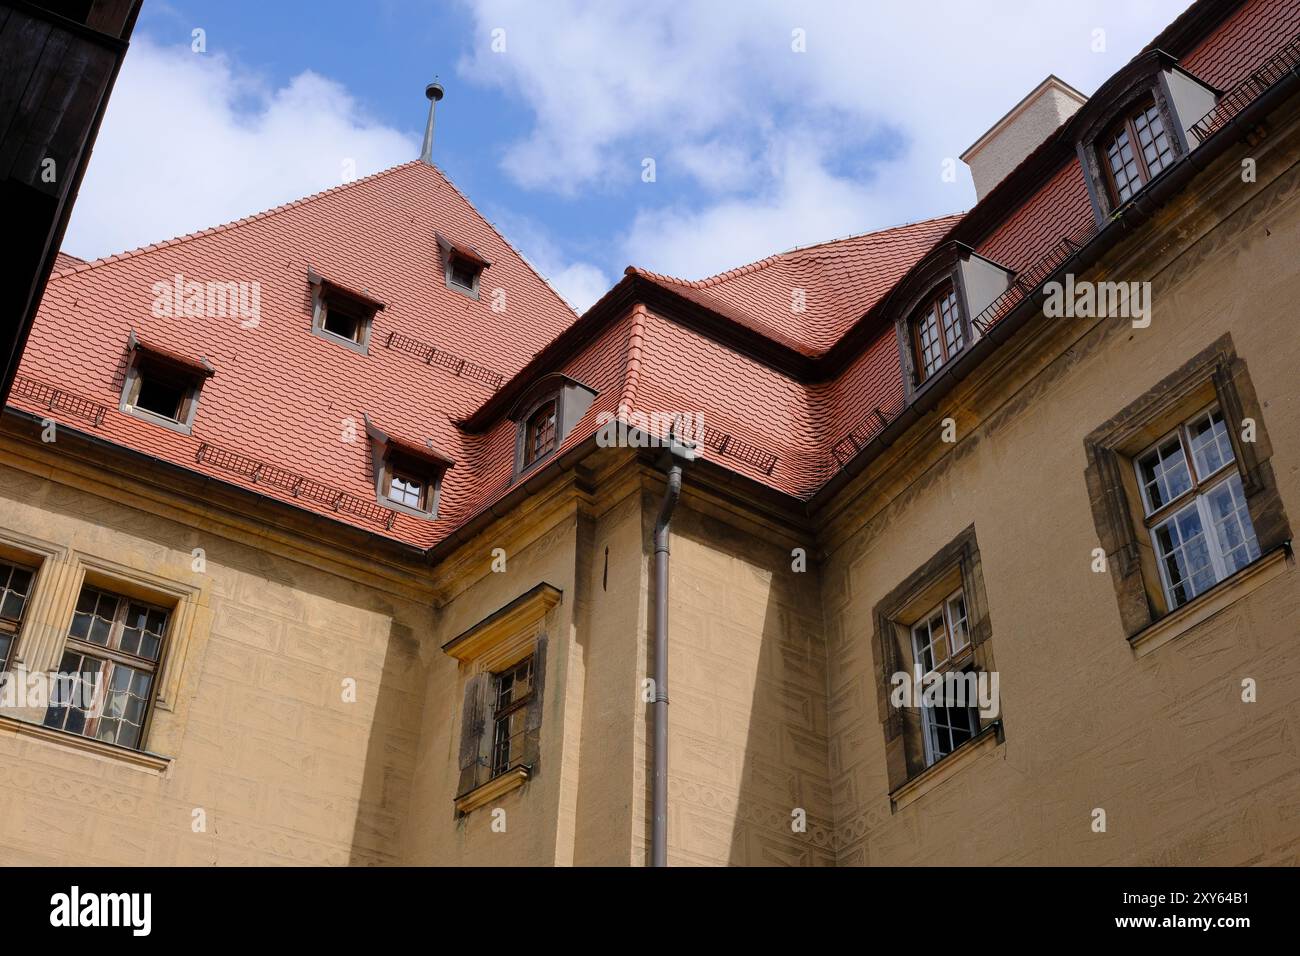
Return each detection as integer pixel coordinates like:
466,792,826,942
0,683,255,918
10,0,1300,546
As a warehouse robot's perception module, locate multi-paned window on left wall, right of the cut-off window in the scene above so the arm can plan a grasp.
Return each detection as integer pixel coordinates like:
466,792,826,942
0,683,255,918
44,585,170,749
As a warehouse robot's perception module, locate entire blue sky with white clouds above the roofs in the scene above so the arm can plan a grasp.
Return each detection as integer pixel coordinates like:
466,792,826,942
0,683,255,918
65,0,1186,308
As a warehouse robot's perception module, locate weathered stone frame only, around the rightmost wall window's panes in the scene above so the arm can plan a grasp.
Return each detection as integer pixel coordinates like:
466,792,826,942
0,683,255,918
1083,334,1291,643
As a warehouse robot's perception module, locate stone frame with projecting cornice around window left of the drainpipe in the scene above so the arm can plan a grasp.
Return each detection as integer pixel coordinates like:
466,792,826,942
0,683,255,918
442,581,563,817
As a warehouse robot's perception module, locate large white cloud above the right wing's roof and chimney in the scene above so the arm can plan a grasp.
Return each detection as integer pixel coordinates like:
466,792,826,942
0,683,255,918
460,0,1187,276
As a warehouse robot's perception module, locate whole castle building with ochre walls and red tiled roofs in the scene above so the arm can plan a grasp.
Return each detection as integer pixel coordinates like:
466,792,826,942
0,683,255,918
0,0,1300,866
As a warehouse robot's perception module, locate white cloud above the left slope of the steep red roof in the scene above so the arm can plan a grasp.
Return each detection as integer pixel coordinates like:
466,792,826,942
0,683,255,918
64,35,419,259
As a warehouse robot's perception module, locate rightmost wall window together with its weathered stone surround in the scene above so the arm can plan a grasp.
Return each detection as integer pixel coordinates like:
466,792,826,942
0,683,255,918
1083,334,1291,649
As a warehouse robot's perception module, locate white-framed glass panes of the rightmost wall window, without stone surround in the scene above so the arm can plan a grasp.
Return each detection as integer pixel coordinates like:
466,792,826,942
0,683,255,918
1135,406,1260,610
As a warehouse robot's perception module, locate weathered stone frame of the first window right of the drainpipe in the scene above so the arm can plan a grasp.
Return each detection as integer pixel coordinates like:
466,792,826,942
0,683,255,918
871,524,1005,809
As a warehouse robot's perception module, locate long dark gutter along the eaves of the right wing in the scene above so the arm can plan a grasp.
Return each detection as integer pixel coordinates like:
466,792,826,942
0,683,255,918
807,55,1300,515
